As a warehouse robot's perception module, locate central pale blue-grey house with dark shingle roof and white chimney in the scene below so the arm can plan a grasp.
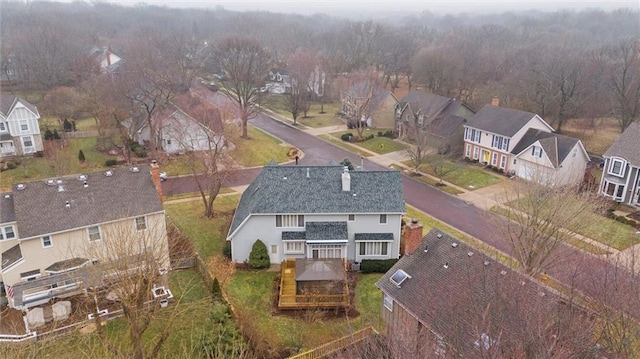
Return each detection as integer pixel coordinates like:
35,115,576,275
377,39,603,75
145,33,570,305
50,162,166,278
227,164,405,264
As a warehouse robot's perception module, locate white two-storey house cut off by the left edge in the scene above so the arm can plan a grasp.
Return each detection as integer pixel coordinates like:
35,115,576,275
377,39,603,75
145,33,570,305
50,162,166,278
0,95,42,157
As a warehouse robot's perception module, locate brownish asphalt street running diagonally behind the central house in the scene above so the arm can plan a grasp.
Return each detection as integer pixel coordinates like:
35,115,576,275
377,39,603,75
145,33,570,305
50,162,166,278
163,109,639,314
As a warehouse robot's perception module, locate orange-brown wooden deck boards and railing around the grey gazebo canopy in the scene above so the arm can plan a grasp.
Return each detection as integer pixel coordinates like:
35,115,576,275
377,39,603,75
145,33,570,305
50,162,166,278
278,259,349,309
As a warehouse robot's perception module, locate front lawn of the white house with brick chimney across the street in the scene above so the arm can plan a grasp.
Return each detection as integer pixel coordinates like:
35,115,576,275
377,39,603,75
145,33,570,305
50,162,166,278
402,160,504,191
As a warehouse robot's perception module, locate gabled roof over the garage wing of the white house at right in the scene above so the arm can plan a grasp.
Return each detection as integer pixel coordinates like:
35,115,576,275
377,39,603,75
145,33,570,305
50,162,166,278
511,128,586,168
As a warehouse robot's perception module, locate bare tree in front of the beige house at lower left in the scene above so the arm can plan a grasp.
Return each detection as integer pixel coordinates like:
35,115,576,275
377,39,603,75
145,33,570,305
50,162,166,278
82,215,172,359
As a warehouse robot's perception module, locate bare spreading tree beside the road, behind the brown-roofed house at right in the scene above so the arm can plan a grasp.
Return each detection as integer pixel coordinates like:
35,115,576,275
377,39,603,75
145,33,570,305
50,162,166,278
496,180,603,276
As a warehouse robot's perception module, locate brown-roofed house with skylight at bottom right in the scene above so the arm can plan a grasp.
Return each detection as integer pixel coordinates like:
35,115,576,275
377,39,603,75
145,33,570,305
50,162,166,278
376,228,592,358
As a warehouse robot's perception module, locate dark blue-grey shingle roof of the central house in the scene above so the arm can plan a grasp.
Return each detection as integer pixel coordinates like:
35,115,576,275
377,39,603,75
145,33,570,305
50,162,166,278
229,165,405,238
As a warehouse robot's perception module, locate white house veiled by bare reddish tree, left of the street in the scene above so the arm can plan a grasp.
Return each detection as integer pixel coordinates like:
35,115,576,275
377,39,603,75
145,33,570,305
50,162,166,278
128,92,225,154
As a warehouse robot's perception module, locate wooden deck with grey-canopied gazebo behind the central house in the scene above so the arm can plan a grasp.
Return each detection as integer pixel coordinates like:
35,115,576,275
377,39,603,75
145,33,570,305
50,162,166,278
278,258,349,309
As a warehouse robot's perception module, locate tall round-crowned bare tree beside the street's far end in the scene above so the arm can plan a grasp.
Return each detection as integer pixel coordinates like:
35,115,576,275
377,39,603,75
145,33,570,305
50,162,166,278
214,36,270,139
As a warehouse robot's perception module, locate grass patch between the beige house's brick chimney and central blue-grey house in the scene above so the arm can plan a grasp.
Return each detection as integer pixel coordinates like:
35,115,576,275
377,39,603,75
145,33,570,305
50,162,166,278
164,195,240,261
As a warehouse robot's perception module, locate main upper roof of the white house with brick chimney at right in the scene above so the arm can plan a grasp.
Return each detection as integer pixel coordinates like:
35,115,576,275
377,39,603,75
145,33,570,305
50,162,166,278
467,105,553,137
